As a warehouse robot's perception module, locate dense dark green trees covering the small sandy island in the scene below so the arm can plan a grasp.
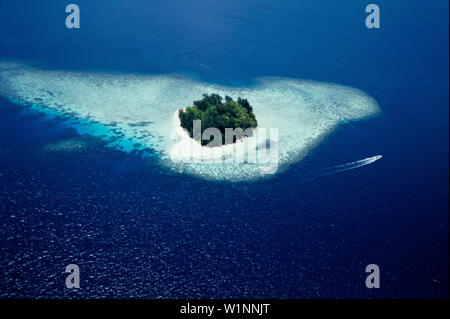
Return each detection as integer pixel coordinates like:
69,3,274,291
178,93,258,145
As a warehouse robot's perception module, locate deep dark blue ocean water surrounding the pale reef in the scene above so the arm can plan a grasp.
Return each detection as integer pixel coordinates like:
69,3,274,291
0,0,449,298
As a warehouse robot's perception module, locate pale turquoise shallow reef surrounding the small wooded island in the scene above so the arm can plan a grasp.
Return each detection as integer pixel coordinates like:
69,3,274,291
0,61,379,181
